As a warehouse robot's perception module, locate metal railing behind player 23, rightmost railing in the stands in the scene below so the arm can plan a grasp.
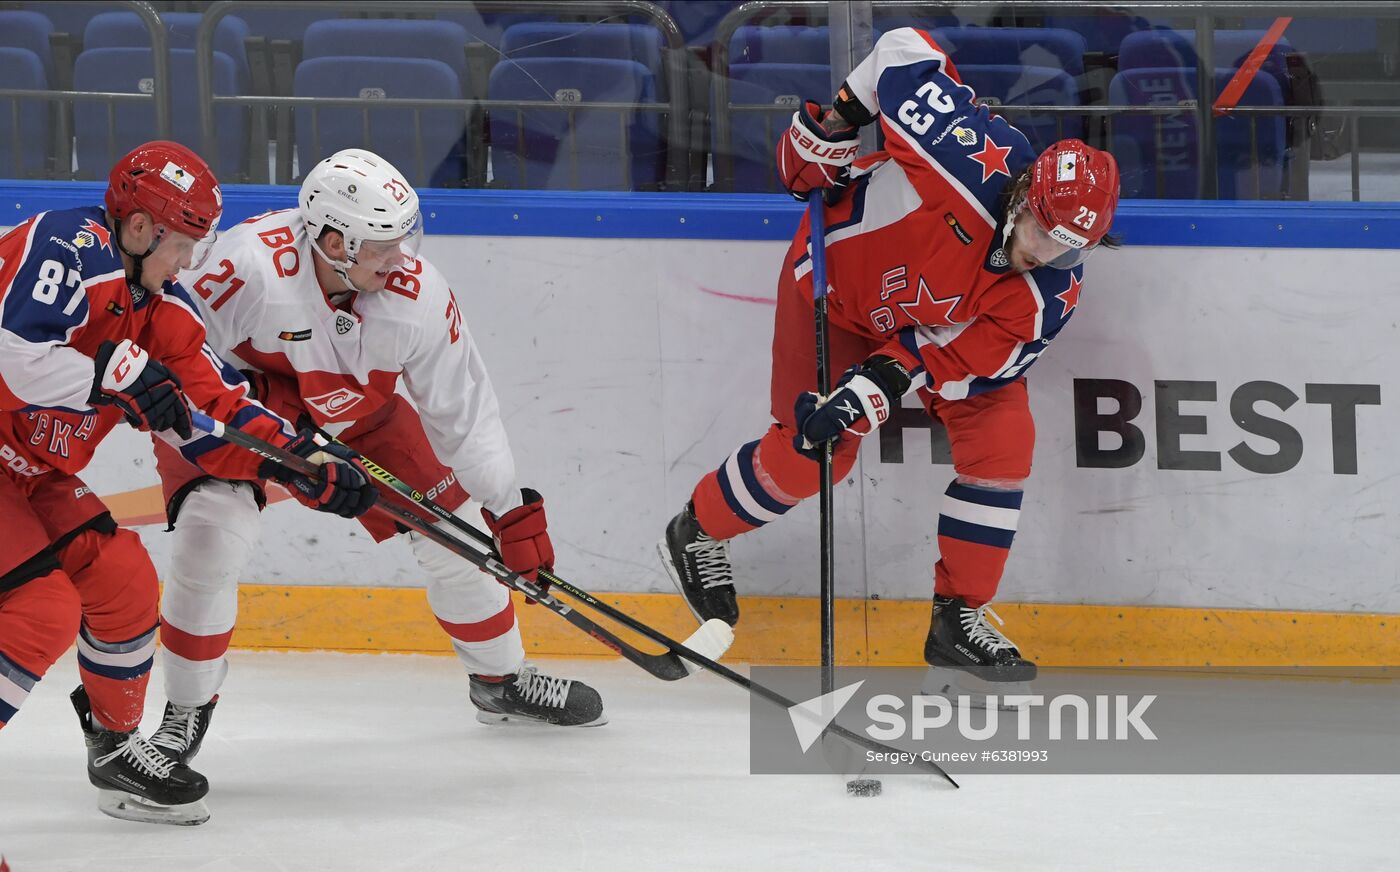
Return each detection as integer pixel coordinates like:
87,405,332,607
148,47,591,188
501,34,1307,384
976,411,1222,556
711,0,1400,199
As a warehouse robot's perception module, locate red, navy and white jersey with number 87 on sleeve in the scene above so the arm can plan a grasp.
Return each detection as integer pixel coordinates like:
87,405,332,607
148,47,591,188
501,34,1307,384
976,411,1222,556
0,206,291,479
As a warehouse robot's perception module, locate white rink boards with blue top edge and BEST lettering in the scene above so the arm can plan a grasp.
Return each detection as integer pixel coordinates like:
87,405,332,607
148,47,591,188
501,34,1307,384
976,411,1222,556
2,192,1400,662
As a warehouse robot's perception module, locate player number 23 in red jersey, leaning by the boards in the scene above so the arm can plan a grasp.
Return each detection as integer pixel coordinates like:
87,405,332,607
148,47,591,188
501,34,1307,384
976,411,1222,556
659,28,1119,683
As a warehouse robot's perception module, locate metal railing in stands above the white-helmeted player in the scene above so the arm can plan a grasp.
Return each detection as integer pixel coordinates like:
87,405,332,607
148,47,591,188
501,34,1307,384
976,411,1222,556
195,0,689,188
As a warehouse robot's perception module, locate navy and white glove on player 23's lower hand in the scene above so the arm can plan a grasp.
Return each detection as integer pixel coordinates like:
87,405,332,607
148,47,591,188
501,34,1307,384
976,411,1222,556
792,354,911,451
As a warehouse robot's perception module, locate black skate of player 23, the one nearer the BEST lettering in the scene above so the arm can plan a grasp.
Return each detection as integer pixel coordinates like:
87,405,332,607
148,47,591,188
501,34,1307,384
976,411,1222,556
924,596,1036,708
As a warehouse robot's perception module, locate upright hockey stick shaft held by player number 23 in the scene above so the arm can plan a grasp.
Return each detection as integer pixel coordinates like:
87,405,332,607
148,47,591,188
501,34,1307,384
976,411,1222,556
808,192,836,693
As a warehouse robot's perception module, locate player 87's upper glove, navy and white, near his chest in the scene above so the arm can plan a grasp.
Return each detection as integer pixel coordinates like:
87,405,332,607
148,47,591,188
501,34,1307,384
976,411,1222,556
88,339,193,439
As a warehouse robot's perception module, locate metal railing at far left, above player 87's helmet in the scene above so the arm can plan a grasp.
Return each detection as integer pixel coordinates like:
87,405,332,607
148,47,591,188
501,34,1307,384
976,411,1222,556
0,0,171,178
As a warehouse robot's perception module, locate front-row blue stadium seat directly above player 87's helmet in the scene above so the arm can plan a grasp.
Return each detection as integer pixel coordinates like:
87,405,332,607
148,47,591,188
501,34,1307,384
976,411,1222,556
73,49,248,179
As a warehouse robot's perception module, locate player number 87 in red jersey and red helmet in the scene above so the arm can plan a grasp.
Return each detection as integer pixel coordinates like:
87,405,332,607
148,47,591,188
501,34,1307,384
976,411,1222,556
0,141,375,823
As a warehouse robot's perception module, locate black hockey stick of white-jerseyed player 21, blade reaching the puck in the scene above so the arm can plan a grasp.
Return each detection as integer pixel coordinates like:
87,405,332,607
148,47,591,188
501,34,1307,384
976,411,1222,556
329,433,958,787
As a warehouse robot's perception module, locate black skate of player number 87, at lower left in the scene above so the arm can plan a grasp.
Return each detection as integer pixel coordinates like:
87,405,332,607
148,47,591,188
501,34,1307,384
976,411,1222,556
70,686,209,826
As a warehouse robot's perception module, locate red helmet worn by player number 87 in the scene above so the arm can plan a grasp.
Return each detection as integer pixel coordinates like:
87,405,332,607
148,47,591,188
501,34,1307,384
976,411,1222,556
106,140,224,239
